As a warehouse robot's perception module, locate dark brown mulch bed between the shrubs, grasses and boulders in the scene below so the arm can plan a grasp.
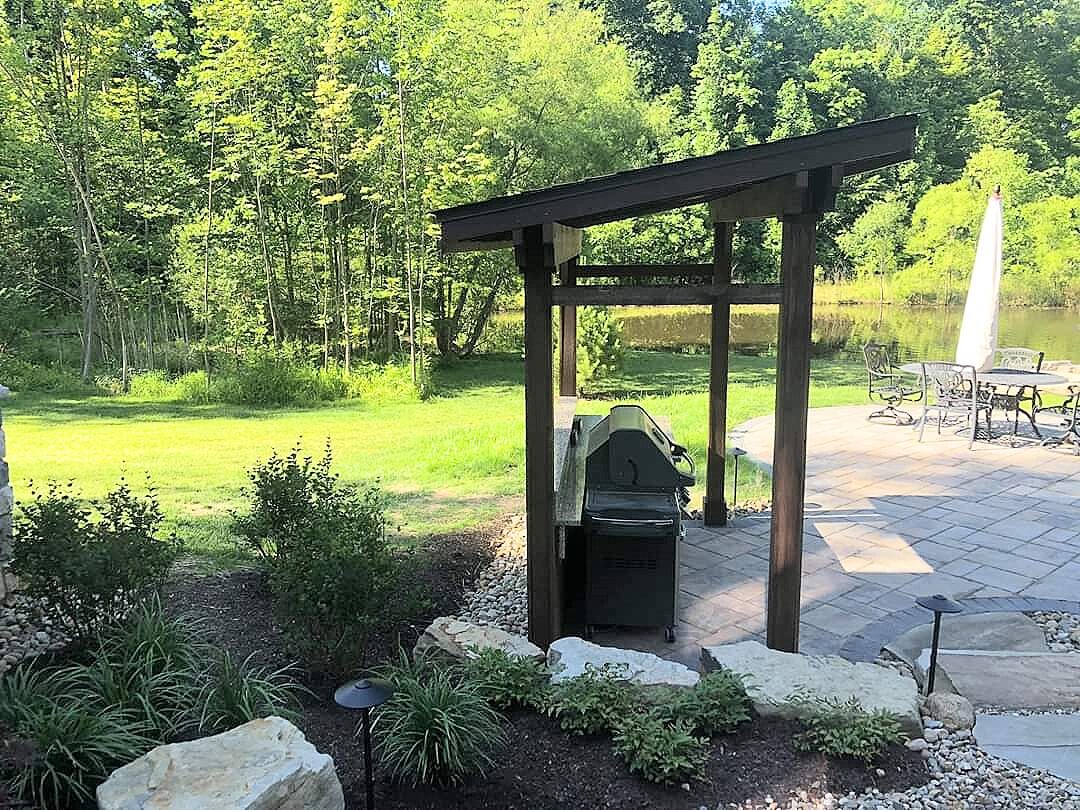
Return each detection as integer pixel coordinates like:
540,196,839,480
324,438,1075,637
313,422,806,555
166,526,927,810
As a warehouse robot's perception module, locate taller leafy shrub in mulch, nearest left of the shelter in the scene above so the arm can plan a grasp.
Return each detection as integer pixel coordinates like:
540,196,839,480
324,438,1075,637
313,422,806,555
234,447,414,673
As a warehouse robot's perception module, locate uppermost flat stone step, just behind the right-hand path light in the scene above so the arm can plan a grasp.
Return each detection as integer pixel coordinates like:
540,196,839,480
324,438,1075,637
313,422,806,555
885,613,1049,666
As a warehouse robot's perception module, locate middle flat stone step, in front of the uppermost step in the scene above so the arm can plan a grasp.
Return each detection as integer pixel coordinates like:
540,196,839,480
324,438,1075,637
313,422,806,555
916,650,1080,708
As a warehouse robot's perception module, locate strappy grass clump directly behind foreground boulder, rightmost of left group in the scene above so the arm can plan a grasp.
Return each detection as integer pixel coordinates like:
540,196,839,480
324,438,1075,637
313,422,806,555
199,651,302,734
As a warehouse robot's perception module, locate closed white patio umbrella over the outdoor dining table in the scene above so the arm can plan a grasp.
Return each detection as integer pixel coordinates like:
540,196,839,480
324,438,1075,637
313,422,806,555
956,186,1003,372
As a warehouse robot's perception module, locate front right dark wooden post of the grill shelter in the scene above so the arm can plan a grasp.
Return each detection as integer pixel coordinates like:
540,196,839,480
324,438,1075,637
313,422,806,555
766,214,818,652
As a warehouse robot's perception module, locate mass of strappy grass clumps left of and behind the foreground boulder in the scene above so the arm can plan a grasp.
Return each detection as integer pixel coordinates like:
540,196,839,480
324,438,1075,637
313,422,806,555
0,599,298,808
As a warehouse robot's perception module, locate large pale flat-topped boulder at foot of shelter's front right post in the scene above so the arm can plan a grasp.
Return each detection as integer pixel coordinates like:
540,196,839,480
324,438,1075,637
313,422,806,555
701,642,922,737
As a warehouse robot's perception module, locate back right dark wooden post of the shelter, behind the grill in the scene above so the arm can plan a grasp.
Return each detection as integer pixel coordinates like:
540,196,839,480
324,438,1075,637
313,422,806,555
704,222,734,526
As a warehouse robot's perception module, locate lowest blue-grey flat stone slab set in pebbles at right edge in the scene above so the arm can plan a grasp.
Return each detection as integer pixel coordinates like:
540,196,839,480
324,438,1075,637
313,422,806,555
975,714,1080,782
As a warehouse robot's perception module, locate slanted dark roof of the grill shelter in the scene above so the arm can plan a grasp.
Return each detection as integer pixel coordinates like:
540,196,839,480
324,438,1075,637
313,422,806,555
435,116,917,251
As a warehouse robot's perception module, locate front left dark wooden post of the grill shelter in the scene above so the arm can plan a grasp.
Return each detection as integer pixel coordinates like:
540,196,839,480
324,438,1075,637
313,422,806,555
515,226,559,648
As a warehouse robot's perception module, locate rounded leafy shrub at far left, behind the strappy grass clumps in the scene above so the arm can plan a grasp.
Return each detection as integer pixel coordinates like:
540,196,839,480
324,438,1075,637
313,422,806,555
12,480,181,640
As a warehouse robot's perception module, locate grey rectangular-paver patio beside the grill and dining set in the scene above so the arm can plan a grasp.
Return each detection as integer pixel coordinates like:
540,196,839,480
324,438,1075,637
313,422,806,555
596,406,1080,664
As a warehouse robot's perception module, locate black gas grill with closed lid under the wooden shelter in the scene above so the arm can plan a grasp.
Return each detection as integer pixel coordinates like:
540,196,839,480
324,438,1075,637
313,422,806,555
582,405,694,642
